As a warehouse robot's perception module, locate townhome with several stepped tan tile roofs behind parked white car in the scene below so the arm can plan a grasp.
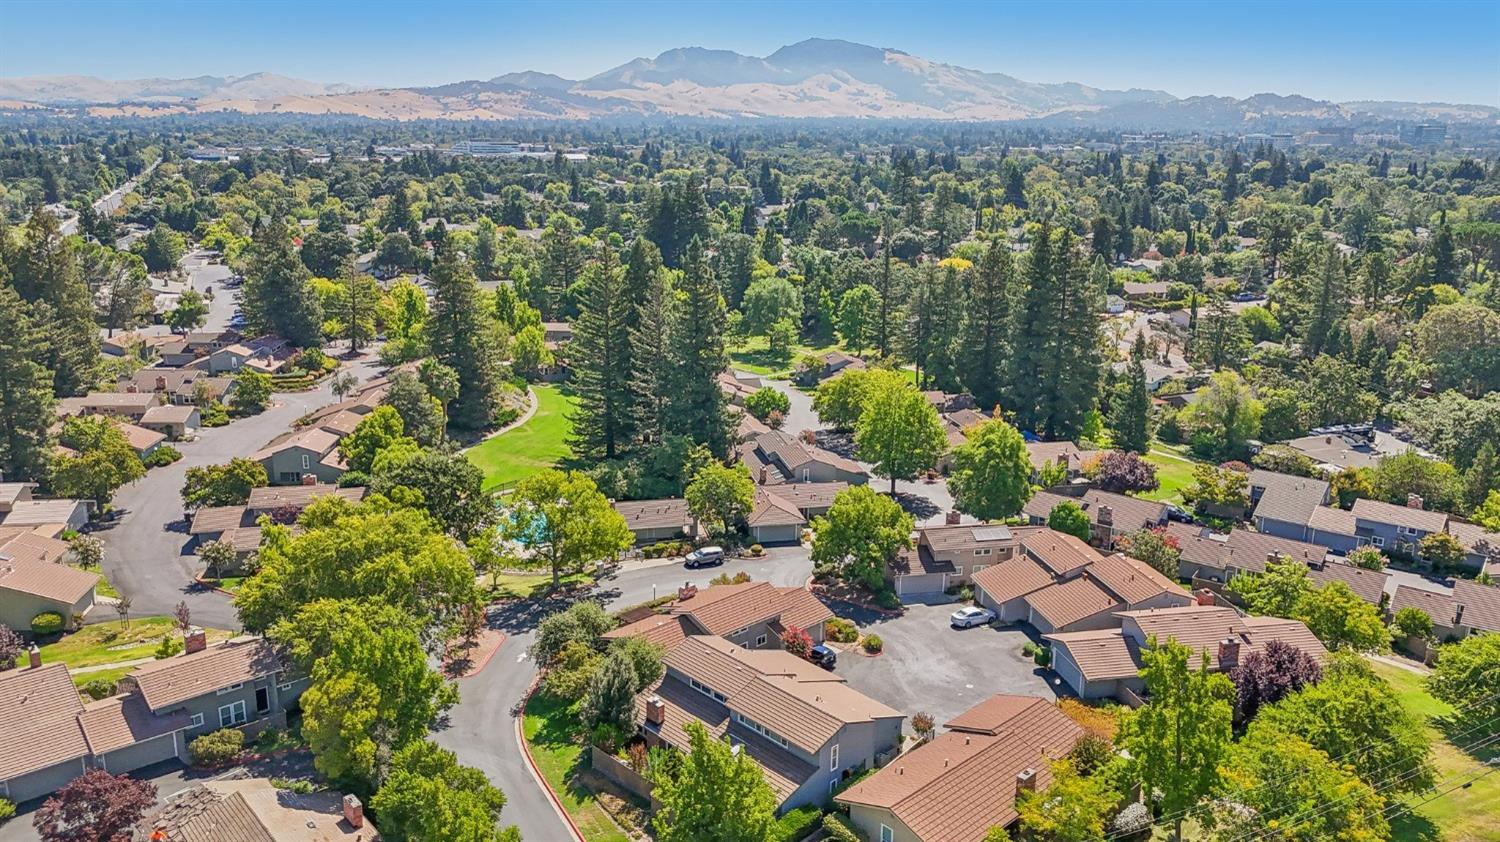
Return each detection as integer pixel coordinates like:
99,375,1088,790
974,528,1193,633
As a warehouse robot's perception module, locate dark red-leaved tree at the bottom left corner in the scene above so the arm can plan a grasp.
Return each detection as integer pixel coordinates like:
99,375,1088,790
32,768,156,842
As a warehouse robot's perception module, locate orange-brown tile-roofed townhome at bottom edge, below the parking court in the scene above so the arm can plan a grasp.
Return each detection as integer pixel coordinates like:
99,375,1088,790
834,695,1085,842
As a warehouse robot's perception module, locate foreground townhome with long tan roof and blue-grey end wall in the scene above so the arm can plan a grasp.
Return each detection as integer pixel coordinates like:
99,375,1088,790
636,635,906,810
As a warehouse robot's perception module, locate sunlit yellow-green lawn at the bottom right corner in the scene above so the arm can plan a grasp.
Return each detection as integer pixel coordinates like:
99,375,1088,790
1371,662,1500,842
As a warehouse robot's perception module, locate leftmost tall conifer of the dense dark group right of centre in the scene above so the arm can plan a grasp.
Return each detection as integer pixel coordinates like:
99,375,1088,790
957,239,1014,411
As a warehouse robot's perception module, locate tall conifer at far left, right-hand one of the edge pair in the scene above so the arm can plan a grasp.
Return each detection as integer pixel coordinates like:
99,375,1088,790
0,209,99,396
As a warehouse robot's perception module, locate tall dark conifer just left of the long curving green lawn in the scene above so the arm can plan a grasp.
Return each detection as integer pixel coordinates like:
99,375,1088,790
426,249,503,429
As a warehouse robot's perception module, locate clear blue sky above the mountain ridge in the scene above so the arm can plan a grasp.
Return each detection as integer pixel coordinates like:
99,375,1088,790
0,0,1500,105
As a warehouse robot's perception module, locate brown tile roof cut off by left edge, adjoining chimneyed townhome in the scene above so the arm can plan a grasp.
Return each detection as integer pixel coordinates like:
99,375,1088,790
0,663,89,780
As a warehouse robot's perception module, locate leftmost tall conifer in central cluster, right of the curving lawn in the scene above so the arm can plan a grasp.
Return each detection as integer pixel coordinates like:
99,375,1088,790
569,243,636,459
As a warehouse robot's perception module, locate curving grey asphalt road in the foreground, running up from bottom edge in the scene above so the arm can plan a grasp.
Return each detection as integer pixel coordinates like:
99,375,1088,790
438,546,812,842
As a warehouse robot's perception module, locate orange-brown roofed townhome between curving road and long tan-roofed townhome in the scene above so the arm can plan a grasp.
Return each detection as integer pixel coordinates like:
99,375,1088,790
603,582,834,650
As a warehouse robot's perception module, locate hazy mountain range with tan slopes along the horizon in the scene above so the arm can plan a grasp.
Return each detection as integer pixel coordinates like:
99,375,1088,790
0,39,1500,128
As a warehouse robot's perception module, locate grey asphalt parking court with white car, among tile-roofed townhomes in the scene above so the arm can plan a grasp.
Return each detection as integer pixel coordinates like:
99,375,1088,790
837,603,1056,725
